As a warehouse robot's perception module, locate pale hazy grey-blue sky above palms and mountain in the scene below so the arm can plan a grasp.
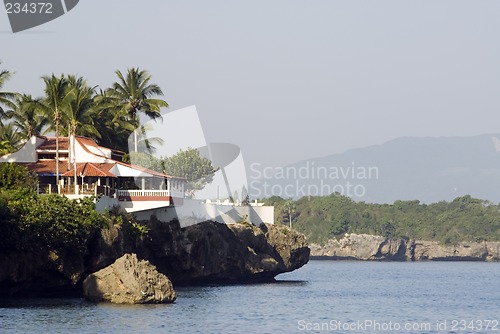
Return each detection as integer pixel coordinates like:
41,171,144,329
0,0,500,166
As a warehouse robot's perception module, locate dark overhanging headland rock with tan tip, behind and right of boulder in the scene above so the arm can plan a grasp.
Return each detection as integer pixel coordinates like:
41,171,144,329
88,219,309,285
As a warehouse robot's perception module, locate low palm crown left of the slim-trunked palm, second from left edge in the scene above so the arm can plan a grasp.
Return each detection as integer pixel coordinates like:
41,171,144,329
8,94,49,140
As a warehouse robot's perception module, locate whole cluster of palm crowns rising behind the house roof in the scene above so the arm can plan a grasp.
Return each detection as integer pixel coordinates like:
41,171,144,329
0,63,168,155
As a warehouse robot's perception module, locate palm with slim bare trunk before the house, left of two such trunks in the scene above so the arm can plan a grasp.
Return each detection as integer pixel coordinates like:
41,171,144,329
40,74,72,185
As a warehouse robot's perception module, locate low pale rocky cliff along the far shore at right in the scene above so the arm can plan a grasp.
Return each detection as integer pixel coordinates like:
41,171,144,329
310,234,500,261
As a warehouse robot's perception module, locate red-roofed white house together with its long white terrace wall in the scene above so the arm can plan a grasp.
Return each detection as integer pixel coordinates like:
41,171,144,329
0,136,274,227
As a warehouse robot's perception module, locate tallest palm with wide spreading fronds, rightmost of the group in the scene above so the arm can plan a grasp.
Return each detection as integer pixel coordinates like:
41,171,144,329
111,68,168,152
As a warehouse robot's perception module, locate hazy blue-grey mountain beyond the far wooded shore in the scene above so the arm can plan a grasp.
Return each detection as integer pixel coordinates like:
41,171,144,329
249,134,500,203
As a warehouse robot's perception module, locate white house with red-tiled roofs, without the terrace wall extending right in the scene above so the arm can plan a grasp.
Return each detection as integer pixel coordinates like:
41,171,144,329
0,136,184,212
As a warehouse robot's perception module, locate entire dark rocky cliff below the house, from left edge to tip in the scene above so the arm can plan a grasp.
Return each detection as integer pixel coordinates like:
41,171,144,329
0,219,309,296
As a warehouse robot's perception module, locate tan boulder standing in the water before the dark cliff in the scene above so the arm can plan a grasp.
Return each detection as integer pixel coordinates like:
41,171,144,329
83,254,175,304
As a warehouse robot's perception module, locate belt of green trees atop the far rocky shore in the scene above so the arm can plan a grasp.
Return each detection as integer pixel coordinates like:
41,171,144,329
264,194,500,244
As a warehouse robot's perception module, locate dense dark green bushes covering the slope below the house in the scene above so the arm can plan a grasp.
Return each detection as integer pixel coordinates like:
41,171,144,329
0,163,149,254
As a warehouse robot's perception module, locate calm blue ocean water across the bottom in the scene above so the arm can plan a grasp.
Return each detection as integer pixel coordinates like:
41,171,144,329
0,261,500,334
